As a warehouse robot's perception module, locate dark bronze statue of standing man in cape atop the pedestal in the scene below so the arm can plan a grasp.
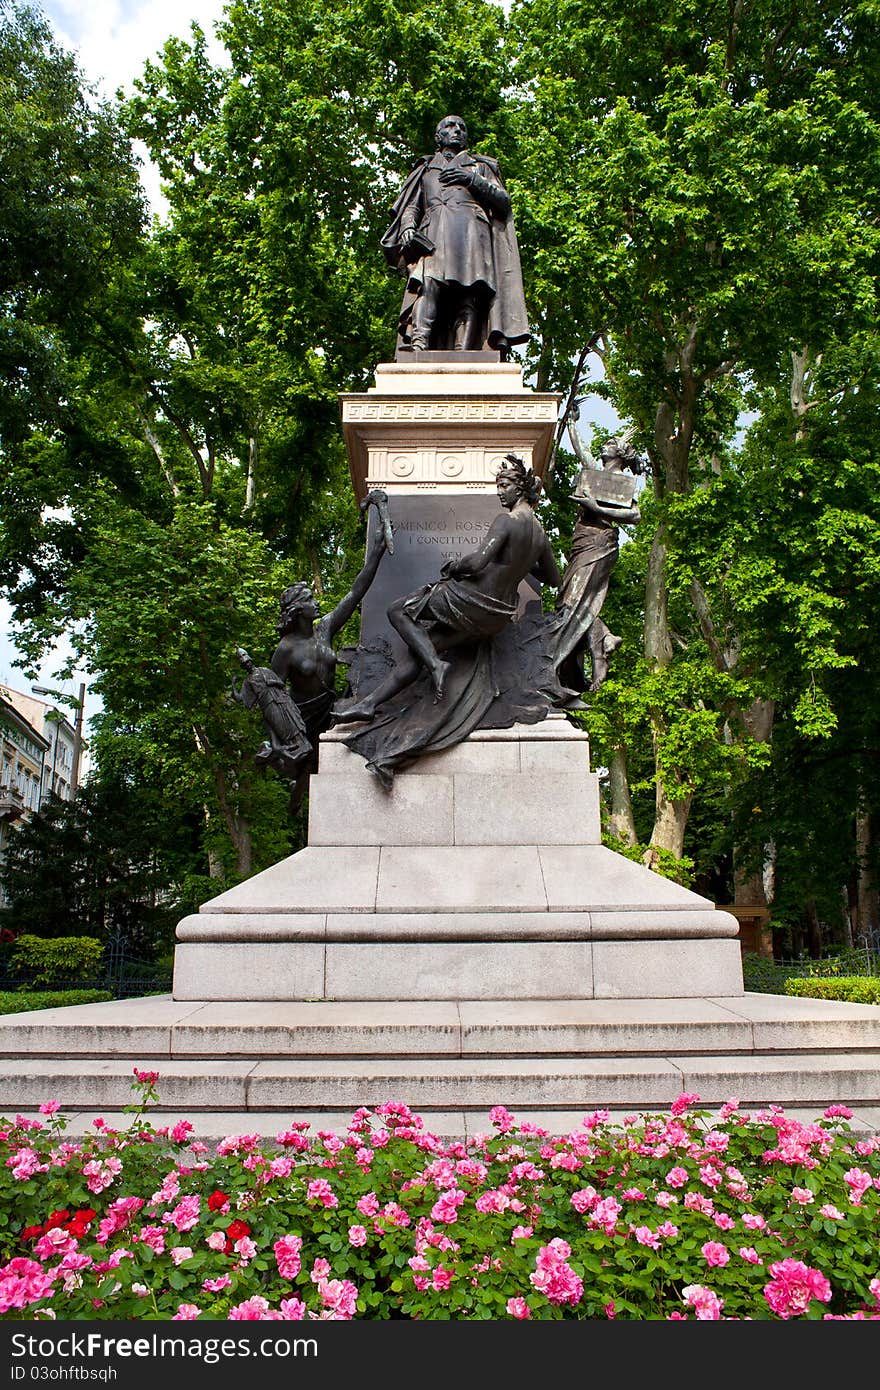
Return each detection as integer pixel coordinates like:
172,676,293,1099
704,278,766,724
382,115,530,357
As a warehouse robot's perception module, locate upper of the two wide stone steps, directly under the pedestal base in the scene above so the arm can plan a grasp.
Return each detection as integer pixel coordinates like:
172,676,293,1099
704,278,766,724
0,994,880,1062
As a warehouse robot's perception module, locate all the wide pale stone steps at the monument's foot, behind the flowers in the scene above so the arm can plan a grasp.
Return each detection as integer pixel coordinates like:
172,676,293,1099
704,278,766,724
0,994,880,1138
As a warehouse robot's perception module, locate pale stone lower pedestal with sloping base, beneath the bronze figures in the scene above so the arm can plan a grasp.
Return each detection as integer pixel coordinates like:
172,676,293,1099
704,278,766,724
174,714,742,1001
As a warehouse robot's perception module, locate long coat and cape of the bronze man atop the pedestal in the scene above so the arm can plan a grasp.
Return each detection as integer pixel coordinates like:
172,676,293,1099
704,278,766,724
382,150,530,348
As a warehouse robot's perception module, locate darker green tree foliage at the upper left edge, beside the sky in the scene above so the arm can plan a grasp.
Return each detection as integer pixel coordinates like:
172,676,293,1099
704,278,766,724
0,4,143,450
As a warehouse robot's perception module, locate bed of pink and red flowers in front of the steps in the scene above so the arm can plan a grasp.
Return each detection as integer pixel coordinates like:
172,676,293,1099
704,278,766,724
0,1072,880,1321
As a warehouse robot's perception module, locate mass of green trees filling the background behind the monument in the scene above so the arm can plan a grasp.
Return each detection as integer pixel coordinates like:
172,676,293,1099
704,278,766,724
0,0,880,940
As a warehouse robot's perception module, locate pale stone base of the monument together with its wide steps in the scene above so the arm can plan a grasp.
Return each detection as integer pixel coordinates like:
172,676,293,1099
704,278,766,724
0,717,880,1138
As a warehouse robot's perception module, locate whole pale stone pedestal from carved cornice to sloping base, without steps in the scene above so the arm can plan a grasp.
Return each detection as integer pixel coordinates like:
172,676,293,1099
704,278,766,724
174,353,742,1002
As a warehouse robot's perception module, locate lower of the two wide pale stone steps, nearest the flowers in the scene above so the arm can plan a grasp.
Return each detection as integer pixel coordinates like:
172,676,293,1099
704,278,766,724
0,1051,880,1115
